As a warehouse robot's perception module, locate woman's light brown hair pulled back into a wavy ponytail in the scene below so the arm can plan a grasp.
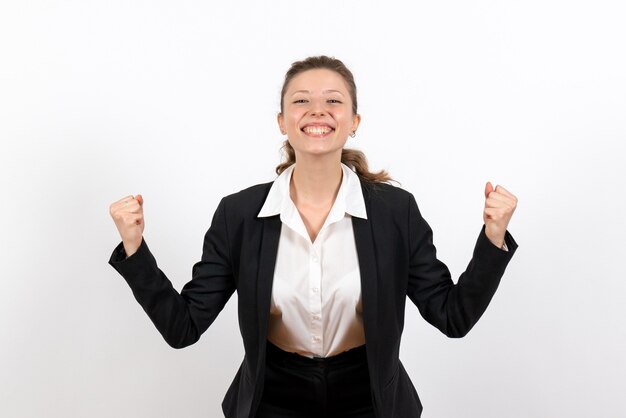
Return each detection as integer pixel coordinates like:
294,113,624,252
276,55,393,183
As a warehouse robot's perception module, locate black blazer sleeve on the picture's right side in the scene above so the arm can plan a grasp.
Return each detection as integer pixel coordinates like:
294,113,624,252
407,195,517,337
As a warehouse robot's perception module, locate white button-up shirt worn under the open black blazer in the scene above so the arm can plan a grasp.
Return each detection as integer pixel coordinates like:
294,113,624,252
258,164,367,357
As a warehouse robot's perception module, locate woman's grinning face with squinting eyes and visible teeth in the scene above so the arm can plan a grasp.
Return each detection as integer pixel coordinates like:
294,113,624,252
278,69,361,160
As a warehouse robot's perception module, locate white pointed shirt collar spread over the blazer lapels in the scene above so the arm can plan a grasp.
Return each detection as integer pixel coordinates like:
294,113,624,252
257,163,367,219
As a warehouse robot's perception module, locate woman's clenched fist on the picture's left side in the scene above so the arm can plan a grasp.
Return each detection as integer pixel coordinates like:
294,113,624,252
109,194,144,257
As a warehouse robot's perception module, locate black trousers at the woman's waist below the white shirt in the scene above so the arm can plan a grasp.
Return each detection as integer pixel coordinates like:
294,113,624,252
256,341,375,418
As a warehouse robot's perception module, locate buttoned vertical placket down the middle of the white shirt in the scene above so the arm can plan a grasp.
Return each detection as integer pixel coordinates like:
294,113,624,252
309,237,324,356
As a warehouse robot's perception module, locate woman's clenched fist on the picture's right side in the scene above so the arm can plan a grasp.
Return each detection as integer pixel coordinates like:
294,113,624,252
483,182,517,248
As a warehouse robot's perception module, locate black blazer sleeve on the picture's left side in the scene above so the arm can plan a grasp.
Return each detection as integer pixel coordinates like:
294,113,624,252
109,200,236,348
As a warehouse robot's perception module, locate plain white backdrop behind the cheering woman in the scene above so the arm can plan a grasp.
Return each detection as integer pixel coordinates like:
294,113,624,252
0,0,626,418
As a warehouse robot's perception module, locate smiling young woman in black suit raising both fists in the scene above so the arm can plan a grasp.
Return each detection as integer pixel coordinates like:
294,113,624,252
109,56,517,418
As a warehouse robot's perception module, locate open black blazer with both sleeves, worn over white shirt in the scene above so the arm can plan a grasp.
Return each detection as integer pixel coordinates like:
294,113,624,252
109,182,517,418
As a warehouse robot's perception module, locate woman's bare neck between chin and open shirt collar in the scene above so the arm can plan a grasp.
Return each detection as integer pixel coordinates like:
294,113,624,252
290,156,343,206
